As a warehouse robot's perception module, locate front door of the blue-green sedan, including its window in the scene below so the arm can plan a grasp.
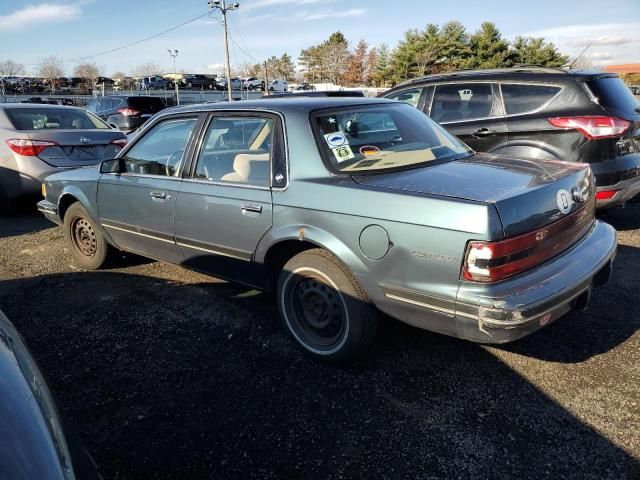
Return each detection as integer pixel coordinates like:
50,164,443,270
97,115,199,262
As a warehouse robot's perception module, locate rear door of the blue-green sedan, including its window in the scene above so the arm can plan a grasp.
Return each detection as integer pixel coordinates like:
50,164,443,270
176,113,283,286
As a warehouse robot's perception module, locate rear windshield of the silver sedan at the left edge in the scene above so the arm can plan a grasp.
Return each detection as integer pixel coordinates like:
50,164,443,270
5,107,111,130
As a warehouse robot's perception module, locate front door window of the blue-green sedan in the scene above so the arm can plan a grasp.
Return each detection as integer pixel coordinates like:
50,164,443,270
123,118,198,177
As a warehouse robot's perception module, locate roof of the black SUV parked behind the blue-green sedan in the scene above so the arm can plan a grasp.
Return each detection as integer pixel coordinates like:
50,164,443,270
392,65,618,90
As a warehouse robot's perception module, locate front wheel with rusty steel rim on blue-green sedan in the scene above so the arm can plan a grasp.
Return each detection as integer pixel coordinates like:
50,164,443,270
64,202,111,270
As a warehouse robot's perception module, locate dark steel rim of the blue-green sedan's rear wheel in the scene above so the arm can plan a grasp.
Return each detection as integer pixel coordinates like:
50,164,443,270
284,271,348,352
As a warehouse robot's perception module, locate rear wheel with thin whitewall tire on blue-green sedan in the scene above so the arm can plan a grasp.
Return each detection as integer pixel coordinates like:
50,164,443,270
277,248,378,363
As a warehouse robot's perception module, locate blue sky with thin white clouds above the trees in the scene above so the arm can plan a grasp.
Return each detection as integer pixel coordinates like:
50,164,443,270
0,0,640,75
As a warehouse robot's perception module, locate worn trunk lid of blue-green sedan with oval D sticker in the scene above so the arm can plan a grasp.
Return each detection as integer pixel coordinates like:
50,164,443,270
353,154,595,237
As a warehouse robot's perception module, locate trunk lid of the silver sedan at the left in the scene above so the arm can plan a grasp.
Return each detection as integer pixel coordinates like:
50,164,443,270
27,129,126,167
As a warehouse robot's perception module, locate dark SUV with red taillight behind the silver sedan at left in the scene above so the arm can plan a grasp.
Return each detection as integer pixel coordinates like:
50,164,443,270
86,95,166,132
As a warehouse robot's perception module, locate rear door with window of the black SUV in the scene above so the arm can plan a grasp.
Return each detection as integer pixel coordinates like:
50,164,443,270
428,82,508,152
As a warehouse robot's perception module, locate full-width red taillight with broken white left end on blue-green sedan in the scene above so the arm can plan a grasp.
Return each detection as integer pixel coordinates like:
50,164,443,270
462,198,595,283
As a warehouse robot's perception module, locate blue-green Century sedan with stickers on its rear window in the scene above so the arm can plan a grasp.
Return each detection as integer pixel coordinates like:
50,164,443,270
39,96,617,362
